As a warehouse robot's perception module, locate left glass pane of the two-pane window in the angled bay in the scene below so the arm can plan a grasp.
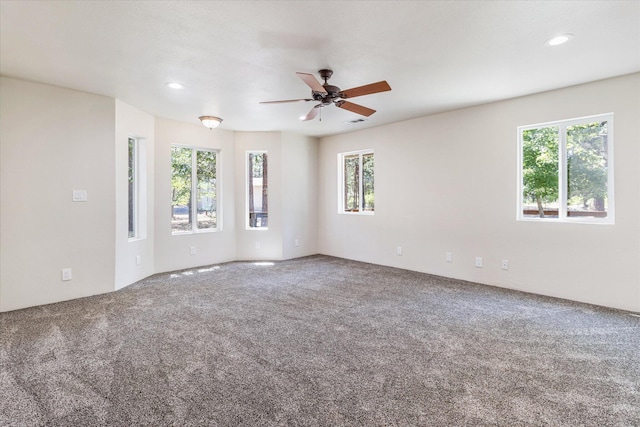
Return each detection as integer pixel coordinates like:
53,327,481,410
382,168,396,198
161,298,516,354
171,147,192,233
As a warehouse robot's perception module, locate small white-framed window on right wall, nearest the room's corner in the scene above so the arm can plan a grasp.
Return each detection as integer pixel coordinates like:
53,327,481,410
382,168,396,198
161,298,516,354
338,150,375,214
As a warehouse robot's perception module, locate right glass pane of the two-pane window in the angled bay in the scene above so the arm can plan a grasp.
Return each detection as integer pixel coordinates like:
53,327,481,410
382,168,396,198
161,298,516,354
196,151,217,229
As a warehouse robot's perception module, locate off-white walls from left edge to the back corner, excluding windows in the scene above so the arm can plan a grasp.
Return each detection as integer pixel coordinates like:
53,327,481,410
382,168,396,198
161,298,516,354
0,82,318,311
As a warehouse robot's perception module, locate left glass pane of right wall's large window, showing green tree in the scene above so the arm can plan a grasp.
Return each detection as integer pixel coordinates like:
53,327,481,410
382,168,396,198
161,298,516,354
521,126,559,218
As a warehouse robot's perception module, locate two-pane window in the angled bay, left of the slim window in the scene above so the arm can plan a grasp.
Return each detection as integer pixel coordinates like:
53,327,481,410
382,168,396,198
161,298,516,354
171,146,218,233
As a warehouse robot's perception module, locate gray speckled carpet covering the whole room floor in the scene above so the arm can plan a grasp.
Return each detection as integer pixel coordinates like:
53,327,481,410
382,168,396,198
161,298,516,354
0,256,640,427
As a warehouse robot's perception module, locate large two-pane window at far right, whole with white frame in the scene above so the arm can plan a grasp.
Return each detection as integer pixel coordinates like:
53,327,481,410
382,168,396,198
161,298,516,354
518,114,614,223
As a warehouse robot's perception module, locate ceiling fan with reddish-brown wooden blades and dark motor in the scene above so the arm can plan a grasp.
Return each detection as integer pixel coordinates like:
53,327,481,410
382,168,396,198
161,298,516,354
260,69,391,121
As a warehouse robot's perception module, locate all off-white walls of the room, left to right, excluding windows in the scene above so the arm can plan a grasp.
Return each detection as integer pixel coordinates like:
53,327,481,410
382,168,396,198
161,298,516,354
0,74,640,311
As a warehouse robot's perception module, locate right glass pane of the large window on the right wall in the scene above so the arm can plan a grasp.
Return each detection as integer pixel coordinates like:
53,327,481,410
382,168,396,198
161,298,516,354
567,121,608,218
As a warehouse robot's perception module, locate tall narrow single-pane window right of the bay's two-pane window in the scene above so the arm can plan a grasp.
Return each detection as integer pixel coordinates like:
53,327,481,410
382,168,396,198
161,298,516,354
247,151,269,229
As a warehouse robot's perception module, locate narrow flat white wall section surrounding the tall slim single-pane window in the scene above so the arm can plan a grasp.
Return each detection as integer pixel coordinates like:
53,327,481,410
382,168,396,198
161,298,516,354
235,132,283,260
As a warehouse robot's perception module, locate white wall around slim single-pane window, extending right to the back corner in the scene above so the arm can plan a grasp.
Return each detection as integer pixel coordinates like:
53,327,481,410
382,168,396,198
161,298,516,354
235,132,318,260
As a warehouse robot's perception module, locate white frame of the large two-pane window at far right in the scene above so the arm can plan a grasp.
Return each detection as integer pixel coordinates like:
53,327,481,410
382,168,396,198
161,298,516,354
516,113,615,224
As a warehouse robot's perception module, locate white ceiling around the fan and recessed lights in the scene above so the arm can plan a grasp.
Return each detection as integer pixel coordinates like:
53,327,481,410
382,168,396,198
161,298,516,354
0,0,640,136
